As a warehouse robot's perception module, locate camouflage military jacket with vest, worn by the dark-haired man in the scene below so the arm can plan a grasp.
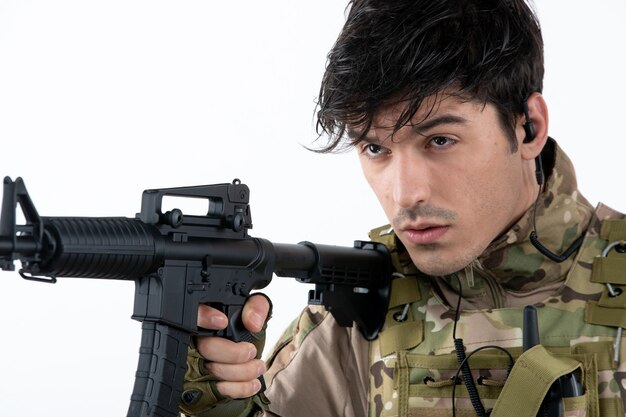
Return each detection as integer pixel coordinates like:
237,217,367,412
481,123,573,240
258,141,626,417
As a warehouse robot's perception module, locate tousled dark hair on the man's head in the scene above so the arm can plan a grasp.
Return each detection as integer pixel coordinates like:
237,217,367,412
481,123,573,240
317,0,544,152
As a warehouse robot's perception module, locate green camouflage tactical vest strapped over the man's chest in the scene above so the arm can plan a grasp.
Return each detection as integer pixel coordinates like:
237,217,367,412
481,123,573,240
369,210,626,417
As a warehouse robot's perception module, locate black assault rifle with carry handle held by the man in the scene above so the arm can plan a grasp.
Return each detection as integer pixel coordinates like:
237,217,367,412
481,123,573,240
0,177,391,417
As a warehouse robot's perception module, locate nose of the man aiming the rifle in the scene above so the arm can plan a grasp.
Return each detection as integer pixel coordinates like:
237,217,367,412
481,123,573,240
391,153,431,208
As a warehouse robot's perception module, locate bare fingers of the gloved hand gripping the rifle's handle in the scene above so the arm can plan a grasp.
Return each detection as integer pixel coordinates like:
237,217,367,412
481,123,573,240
196,295,270,398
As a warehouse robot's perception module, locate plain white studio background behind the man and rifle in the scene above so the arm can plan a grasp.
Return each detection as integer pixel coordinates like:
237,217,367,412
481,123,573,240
0,0,626,417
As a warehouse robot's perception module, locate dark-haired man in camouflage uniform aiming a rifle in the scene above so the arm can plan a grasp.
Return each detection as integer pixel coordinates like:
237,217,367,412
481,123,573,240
182,0,626,417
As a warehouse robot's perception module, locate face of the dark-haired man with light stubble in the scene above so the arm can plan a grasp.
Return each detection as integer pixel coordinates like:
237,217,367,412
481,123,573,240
357,97,538,275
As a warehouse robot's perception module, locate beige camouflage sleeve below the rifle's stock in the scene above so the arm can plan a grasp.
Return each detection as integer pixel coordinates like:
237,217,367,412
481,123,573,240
265,306,369,417
